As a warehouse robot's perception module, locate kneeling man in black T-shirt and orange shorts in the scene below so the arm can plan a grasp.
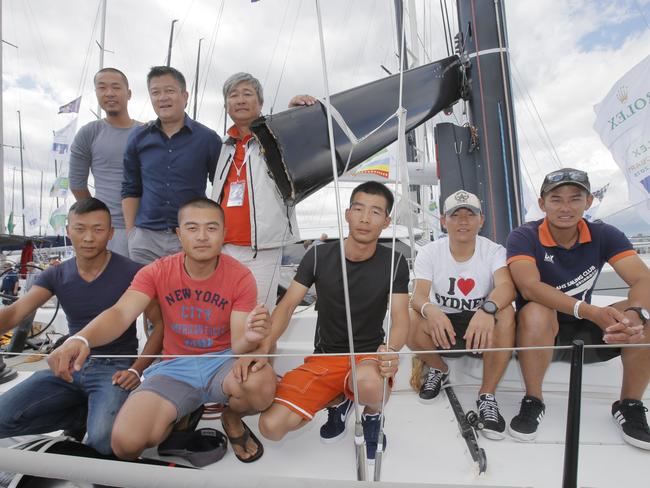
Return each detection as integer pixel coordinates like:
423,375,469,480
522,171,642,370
260,182,409,460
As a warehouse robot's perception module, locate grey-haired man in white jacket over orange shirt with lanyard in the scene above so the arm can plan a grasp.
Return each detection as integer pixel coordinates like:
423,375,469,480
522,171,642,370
212,73,315,311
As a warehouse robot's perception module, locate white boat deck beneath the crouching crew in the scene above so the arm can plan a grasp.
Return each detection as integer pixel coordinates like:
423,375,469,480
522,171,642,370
0,298,650,488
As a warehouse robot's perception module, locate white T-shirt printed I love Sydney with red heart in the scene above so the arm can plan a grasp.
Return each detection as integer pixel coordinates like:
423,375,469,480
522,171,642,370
415,236,506,313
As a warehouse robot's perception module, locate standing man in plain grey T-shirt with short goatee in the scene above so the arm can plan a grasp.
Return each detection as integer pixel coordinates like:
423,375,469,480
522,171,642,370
69,68,141,257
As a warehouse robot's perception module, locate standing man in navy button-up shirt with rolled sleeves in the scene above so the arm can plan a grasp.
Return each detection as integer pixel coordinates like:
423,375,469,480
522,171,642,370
122,66,221,264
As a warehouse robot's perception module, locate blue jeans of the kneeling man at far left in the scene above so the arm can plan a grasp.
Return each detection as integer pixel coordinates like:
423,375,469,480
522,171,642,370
0,357,133,454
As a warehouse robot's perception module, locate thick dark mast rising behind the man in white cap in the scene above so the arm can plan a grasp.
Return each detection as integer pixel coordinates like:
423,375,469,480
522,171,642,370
457,0,522,244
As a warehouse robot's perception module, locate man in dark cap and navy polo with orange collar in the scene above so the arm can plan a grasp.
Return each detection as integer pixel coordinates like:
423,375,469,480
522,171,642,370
506,168,650,450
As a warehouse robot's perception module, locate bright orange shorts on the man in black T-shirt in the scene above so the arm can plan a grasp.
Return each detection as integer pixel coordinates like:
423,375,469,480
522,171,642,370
273,354,392,420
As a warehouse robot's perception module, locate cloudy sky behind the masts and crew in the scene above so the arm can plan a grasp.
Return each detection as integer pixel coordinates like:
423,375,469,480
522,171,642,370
2,0,650,236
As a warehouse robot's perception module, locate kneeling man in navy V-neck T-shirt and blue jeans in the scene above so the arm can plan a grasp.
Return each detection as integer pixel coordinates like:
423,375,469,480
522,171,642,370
0,198,162,454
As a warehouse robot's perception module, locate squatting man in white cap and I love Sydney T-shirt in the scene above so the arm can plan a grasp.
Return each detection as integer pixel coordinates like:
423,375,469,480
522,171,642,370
408,190,515,439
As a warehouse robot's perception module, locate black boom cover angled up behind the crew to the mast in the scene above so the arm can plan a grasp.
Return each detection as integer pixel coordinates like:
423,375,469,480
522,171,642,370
251,56,461,205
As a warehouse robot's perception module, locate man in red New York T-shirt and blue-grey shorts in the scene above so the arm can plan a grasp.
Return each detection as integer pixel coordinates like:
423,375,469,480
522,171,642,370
49,198,276,462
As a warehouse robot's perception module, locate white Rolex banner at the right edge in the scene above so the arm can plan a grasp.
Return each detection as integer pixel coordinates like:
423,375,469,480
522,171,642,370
594,56,650,222
